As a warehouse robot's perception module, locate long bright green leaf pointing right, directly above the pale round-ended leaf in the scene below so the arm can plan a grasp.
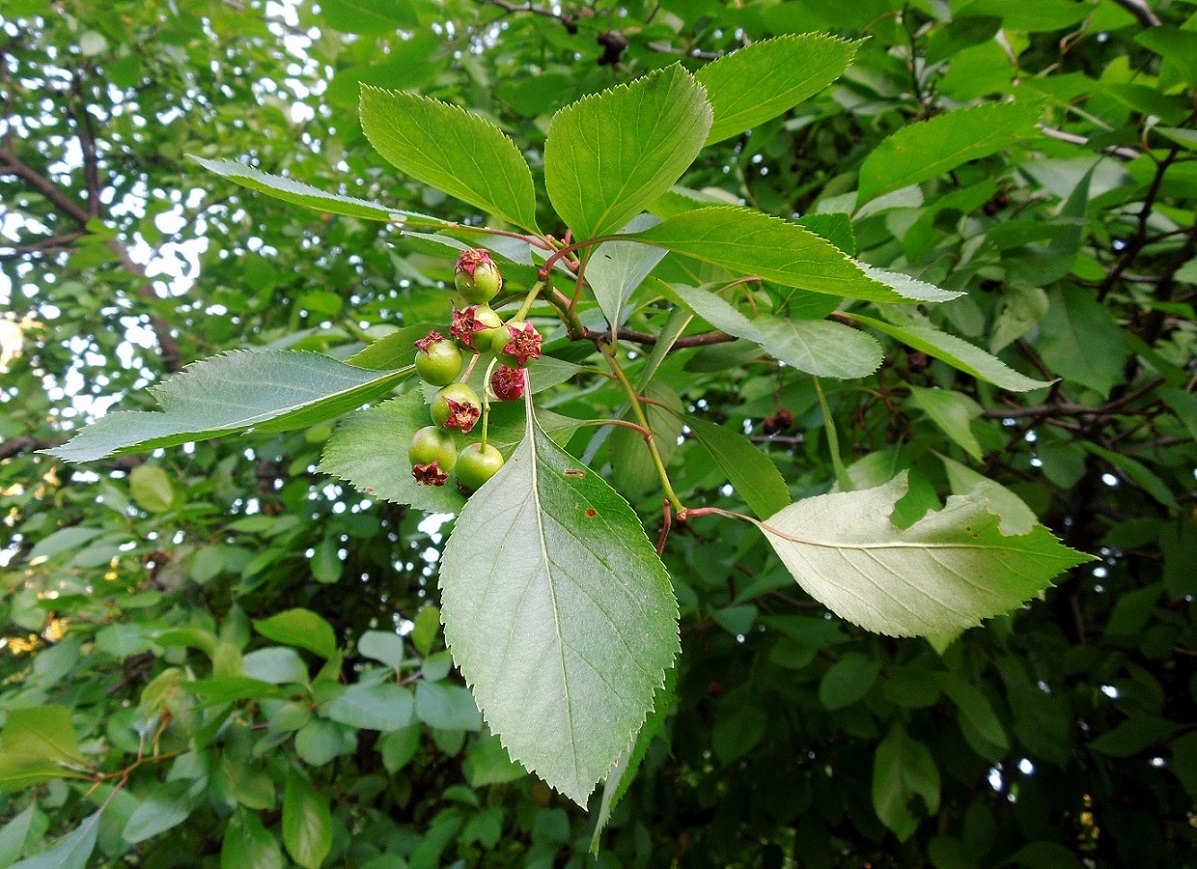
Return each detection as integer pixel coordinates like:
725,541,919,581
630,206,907,303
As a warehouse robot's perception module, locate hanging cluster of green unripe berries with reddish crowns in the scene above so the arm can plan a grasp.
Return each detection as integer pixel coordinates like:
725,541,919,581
407,249,541,494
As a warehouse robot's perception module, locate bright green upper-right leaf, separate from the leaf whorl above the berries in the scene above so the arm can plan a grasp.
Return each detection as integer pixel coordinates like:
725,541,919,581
857,103,1043,207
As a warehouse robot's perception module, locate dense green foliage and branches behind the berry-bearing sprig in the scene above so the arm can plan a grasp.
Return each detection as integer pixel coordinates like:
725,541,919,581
0,0,1197,869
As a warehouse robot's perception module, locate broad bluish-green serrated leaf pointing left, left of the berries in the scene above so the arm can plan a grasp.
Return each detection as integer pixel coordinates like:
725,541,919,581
45,351,411,462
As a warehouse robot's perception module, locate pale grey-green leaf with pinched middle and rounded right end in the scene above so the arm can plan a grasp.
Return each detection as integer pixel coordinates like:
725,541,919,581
668,278,882,378
